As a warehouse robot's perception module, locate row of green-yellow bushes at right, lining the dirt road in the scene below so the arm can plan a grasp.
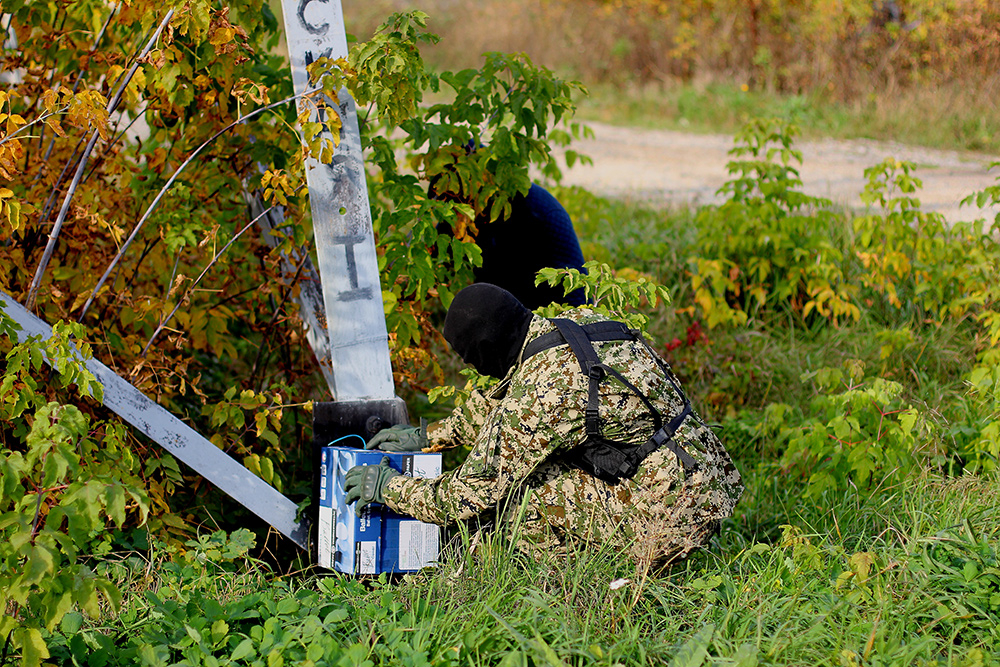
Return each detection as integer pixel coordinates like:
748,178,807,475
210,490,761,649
690,120,1000,334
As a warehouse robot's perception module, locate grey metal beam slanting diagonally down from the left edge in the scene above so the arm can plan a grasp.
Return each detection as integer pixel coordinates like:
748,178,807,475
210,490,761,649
0,292,309,549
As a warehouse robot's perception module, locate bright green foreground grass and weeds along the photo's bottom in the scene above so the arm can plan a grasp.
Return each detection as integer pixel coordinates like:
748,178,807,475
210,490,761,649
54,468,1000,667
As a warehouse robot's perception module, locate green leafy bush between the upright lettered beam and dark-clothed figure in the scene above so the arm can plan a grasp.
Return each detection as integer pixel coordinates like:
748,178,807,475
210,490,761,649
310,11,586,391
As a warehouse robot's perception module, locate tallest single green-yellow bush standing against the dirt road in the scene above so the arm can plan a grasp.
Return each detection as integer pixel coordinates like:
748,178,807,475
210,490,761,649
689,120,860,327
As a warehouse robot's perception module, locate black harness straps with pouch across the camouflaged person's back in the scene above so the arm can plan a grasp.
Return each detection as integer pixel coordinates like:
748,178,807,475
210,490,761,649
522,318,698,484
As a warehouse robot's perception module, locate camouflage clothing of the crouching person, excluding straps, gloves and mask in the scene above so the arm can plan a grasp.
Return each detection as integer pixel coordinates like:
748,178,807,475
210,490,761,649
383,309,743,552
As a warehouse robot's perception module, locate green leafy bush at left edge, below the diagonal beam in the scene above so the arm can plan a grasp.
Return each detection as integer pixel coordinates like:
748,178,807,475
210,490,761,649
0,309,149,665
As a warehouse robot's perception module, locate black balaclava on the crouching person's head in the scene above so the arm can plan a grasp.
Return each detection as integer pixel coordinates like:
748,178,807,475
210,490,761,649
444,283,532,378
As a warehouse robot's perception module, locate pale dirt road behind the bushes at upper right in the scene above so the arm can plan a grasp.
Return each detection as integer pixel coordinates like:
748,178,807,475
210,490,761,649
565,123,1000,222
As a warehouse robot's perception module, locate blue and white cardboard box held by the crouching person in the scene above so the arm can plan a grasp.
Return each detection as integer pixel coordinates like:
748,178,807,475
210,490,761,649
316,447,441,574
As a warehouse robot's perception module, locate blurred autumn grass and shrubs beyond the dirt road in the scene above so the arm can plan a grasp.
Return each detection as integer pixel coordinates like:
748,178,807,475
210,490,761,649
344,0,1000,151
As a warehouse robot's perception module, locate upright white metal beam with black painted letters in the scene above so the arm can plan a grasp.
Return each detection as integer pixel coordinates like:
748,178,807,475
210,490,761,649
282,0,395,402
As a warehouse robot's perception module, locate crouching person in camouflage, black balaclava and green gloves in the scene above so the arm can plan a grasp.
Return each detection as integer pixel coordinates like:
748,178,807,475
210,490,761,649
347,283,743,563
